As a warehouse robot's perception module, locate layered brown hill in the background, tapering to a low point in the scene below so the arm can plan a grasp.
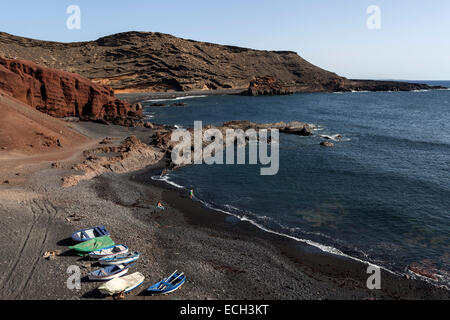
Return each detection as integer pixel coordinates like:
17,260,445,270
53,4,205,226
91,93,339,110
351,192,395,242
0,32,440,93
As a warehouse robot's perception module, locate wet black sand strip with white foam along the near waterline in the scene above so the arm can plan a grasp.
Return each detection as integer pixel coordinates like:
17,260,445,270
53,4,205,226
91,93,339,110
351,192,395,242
146,171,450,299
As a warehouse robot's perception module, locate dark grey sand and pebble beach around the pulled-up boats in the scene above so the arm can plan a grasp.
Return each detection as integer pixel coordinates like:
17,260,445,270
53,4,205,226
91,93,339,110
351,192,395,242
0,123,450,300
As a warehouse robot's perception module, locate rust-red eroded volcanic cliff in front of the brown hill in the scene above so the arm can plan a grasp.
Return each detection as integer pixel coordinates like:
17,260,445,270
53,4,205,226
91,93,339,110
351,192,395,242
0,57,142,124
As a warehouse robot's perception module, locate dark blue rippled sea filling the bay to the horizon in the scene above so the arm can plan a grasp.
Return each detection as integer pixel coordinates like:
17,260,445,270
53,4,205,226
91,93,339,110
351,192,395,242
144,81,450,287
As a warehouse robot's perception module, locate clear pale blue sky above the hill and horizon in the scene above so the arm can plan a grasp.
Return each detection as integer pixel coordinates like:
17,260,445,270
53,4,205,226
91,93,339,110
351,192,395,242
0,0,450,80
